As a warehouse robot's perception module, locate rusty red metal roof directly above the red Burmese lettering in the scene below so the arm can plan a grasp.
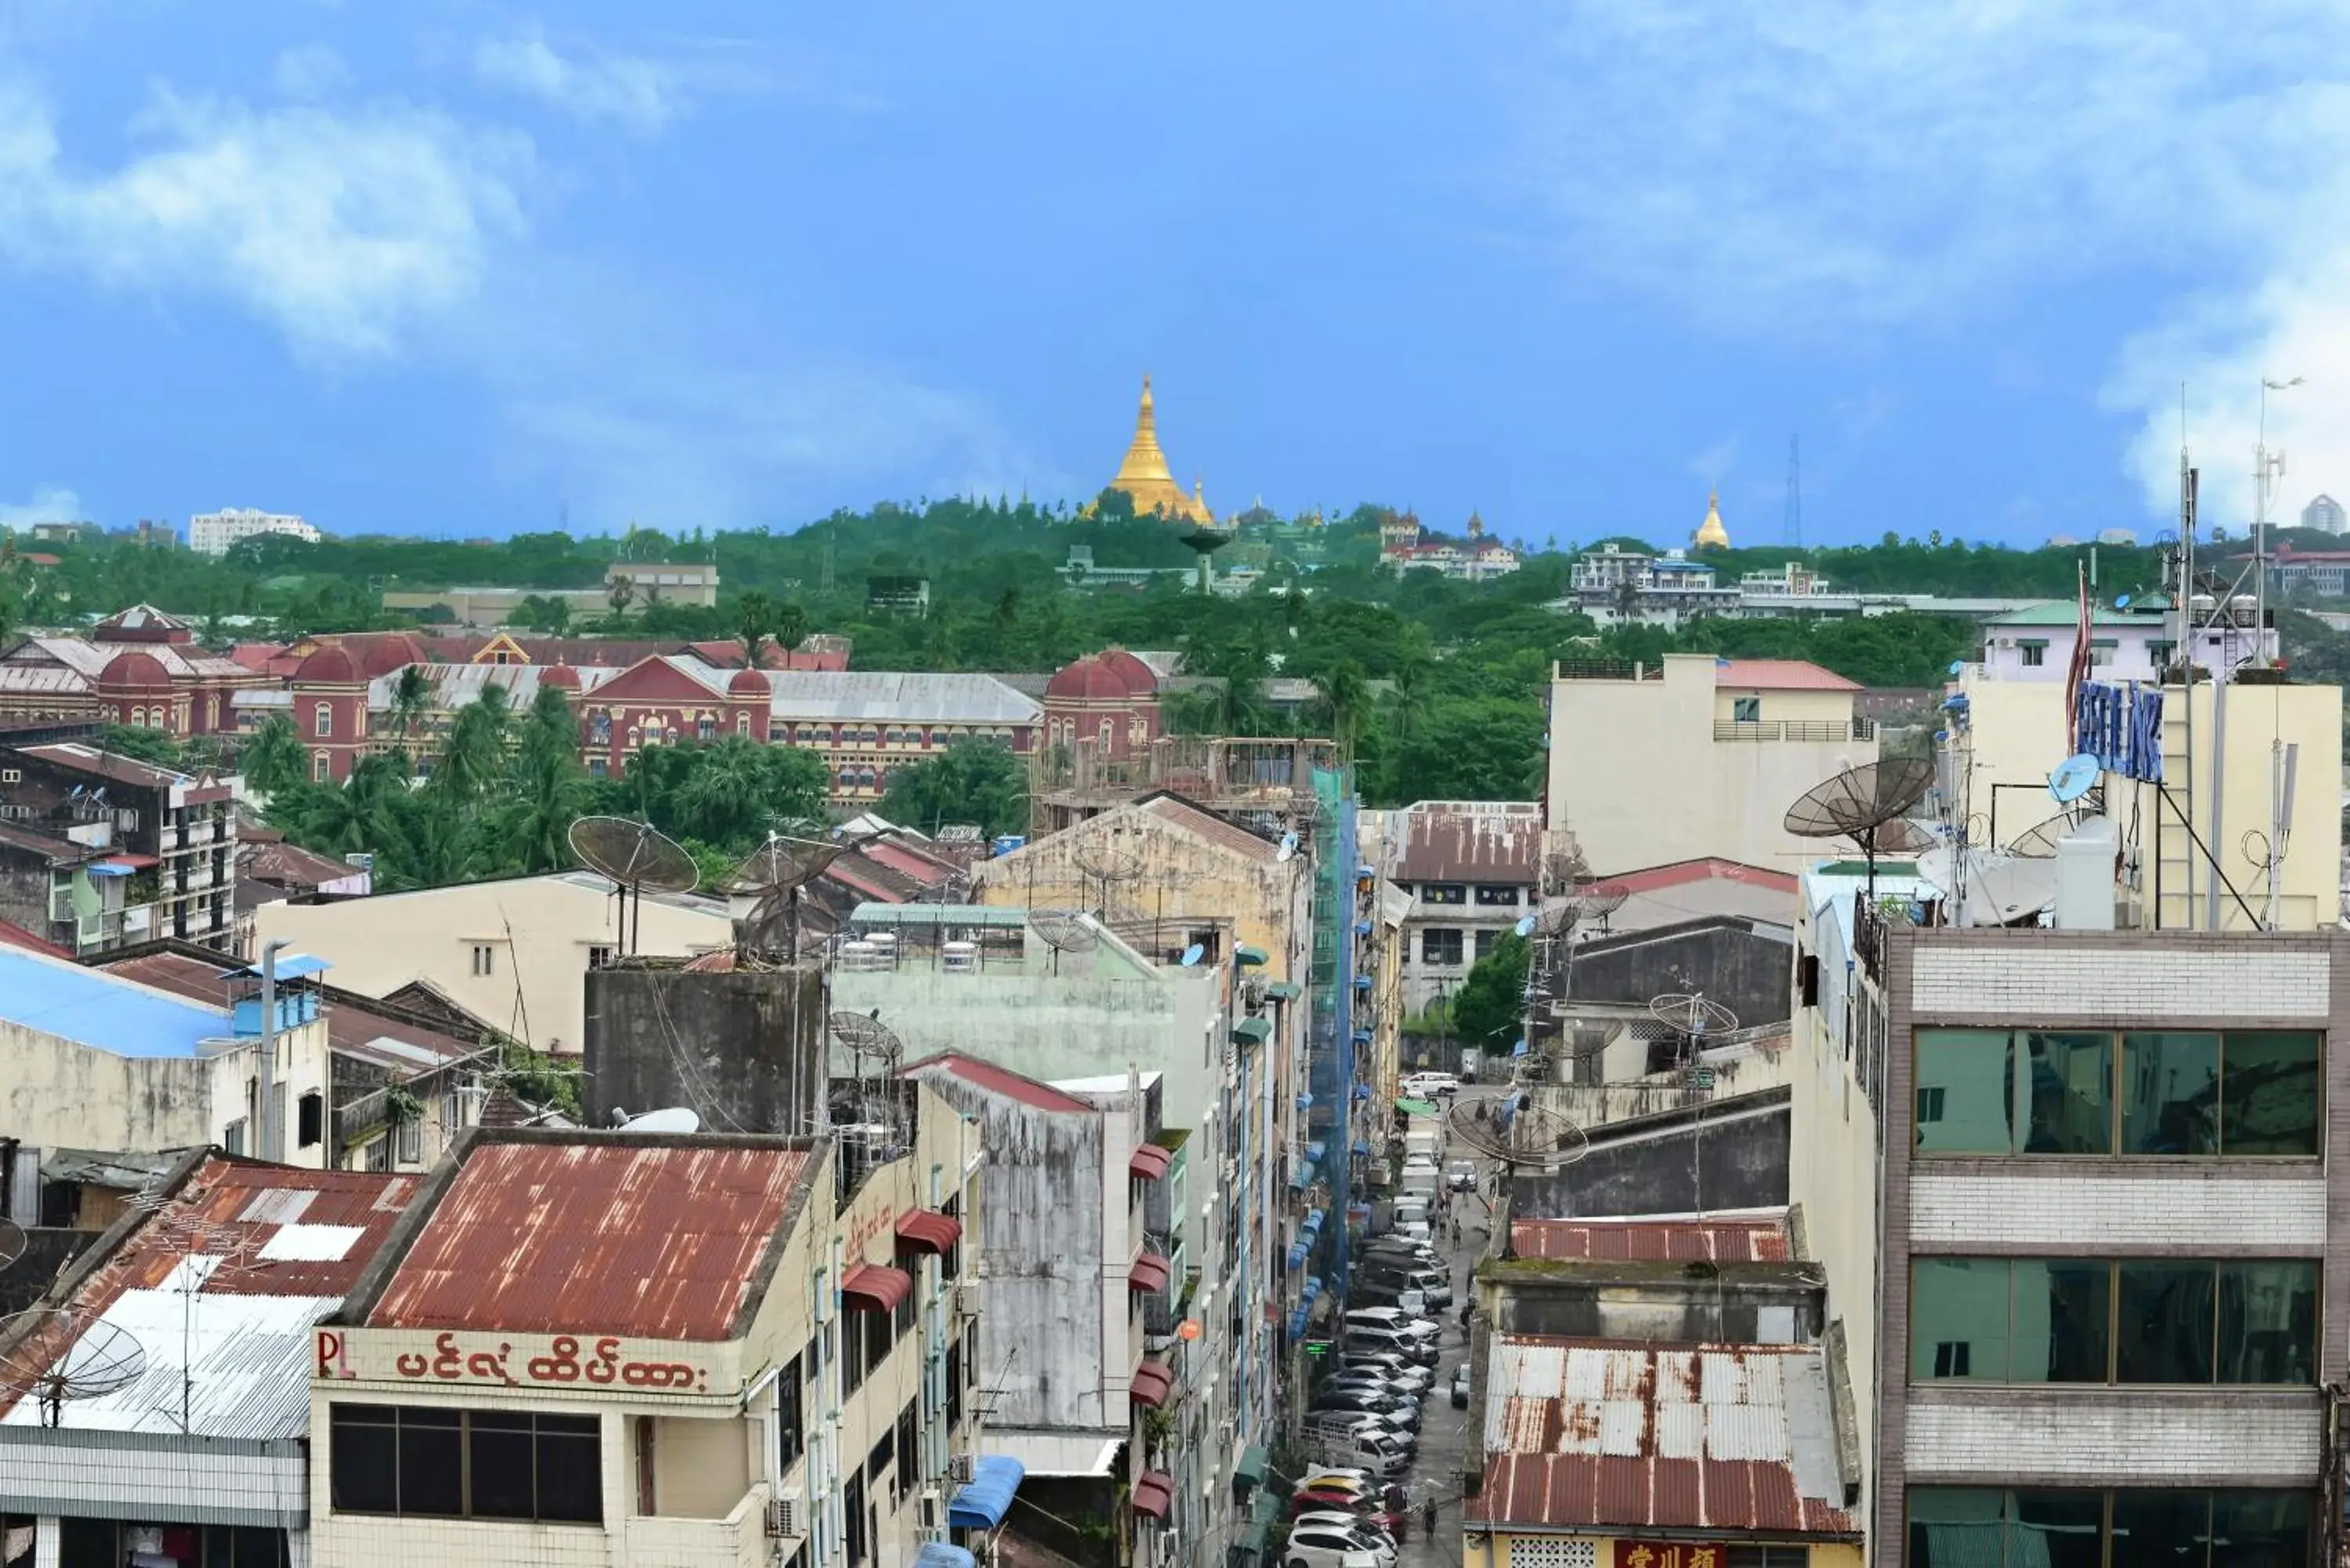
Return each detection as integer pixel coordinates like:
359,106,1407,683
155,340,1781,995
367,1140,811,1340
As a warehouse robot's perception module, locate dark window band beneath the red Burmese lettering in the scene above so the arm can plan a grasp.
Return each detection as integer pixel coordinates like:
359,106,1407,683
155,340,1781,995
329,1404,604,1523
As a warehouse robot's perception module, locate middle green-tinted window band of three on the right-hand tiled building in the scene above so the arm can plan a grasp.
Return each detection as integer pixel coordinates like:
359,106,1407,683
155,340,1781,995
1911,1258,2317,1387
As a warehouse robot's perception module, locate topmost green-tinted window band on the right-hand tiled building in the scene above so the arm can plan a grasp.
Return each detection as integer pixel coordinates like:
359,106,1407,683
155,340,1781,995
1915,1030,2324,1159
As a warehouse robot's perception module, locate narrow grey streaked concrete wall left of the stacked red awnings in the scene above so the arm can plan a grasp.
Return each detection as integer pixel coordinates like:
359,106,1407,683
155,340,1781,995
919,1070,1109,1429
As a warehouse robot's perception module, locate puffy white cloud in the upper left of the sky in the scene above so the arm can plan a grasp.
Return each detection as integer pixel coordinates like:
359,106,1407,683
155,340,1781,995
0,85,531,357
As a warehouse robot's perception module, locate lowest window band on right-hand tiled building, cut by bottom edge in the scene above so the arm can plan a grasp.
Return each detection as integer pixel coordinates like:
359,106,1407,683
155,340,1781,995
1908,1486,2317,1568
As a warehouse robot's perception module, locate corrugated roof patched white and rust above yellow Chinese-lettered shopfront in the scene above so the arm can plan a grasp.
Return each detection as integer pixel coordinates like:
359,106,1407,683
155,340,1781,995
1466,1335,1859,1537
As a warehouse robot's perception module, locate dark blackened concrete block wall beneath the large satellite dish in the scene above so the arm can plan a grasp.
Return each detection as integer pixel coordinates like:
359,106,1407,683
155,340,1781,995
583,962,825,1133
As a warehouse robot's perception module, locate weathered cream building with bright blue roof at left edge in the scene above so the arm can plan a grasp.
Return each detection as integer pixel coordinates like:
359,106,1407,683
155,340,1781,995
0,948,331,1169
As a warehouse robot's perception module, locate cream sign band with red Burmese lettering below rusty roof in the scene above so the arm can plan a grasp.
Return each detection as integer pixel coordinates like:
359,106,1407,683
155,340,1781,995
313,1328,728,1394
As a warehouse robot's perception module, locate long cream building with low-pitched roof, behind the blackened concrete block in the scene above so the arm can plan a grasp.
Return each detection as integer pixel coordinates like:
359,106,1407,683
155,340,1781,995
254,873,733,1053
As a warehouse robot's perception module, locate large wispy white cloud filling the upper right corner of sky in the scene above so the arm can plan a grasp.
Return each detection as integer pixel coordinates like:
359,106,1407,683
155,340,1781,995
1516,0,2350,526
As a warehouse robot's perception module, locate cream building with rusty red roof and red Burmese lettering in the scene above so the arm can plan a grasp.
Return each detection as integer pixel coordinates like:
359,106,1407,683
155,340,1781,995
310,1089,978,1568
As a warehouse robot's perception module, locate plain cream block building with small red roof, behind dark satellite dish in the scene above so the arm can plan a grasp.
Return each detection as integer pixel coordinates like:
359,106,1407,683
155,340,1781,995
1546,653,1878,877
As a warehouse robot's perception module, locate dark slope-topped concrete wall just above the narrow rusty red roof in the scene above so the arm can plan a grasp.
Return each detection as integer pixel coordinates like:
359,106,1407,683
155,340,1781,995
1511,1100,1788,1218
